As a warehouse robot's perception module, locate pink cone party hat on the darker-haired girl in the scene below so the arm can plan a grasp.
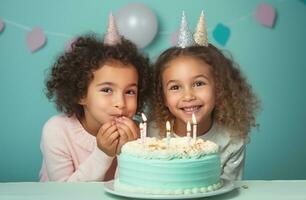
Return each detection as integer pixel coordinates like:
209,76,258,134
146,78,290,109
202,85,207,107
104,13,121,45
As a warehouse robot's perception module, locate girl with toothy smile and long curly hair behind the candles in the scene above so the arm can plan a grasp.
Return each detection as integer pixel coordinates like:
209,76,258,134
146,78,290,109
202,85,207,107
149,12,259,180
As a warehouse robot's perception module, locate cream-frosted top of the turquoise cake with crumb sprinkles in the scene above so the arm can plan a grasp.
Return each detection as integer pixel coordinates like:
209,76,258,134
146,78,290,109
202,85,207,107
121,137,219,160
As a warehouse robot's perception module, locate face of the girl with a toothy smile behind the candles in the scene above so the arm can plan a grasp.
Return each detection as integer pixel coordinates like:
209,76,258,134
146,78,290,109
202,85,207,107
162,56,215,126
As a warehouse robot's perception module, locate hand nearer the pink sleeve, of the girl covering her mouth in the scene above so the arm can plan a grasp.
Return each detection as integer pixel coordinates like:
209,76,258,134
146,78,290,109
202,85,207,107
96,121,119,157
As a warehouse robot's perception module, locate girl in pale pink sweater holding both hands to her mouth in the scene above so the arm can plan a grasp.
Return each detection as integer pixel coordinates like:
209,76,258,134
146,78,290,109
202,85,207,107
40,30,150,181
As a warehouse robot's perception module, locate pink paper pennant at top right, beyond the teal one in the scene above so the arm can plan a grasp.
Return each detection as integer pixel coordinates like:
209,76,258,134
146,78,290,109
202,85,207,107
256,3,276,28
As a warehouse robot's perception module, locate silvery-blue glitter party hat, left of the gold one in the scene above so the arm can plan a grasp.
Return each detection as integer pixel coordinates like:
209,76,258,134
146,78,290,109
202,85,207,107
177,11,195,48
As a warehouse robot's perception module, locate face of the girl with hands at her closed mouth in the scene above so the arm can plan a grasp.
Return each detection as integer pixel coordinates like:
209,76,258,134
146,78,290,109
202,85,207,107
80,61,138,131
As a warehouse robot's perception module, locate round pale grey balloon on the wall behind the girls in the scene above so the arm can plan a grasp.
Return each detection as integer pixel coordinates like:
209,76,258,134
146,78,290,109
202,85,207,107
116,3,158,48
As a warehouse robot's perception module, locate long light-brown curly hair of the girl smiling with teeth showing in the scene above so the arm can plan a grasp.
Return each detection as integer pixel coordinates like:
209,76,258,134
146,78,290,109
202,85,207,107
150,44,260,139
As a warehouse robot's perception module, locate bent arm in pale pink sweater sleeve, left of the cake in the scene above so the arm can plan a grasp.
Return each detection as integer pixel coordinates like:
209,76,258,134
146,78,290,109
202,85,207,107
41,117,112,181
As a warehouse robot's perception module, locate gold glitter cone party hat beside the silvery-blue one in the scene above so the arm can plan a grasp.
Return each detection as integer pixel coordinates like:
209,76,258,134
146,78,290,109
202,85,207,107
193,10,208,47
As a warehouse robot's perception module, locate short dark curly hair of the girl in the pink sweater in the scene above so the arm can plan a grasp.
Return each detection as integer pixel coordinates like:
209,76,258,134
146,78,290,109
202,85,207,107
45,34,150,118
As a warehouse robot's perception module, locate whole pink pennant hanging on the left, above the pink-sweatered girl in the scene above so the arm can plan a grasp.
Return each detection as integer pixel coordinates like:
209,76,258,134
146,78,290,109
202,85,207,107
26,27,46,53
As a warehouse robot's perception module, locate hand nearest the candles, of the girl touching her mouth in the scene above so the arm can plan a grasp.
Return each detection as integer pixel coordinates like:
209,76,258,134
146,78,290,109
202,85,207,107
116,117,139,154
